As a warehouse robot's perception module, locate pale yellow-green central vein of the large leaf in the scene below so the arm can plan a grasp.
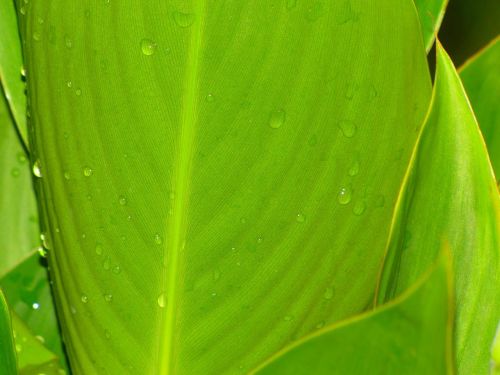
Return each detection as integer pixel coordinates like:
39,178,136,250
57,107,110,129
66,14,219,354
159,0,205,375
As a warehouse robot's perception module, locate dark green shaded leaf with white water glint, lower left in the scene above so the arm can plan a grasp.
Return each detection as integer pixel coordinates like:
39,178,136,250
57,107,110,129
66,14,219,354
0,252,66,374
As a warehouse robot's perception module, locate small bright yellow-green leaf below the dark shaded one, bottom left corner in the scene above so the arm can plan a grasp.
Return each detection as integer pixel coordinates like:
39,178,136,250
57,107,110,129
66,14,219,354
12,313,66,375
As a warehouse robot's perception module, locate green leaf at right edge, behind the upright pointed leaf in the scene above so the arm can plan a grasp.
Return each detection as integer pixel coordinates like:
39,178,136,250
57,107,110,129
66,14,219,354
460,37,500,183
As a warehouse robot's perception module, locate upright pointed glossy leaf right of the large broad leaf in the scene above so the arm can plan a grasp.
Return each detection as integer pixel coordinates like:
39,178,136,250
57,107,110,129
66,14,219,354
379,45,500,374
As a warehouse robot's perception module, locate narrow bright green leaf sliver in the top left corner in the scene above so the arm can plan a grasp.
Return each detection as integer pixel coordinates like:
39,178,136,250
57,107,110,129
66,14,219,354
0,0,30,146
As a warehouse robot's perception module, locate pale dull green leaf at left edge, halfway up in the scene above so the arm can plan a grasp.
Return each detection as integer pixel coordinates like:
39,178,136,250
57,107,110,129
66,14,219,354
0,84,40,277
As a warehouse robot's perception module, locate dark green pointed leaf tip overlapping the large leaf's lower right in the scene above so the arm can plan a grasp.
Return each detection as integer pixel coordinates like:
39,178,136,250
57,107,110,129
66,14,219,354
256,256,453,375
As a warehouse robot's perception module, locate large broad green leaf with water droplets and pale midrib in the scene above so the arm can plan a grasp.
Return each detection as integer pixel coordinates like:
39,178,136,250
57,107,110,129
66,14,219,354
21,0,430,374
